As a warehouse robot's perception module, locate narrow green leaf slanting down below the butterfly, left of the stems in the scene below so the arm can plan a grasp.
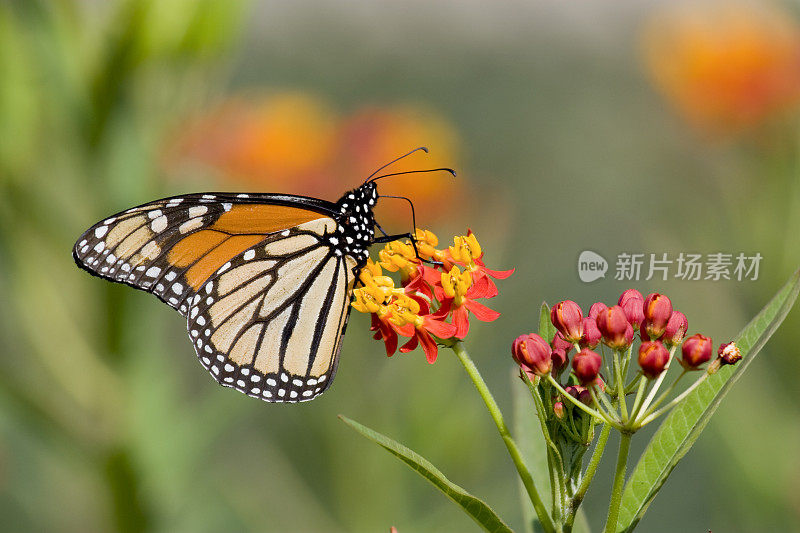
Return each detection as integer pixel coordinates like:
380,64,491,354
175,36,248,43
339,415,513,533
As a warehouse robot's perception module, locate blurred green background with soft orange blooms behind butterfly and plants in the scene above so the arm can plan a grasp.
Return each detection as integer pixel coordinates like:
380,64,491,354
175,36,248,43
0,0,800,533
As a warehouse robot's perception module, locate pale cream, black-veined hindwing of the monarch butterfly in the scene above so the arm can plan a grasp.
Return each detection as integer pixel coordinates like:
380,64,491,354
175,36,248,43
187,219,356,402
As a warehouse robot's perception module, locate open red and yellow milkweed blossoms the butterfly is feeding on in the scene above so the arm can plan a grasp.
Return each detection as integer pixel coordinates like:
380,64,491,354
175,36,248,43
352,229,513,363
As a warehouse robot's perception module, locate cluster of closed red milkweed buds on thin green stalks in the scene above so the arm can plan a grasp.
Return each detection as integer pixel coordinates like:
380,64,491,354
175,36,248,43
511,289,741,432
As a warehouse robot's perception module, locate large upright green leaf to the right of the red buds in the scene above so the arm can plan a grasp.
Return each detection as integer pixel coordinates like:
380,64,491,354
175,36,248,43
617,271,800,531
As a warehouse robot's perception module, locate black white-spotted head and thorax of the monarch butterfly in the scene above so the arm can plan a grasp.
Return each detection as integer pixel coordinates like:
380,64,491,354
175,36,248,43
332,182,378,262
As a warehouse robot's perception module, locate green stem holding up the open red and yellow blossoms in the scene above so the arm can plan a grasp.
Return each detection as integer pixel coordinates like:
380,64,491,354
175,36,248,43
451,341,556,533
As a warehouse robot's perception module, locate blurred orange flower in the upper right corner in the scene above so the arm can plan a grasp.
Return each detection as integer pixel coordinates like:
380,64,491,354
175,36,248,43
644,1,800,134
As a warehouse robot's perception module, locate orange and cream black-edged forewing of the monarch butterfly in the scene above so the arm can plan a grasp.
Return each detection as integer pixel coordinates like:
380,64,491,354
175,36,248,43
73,194,334,314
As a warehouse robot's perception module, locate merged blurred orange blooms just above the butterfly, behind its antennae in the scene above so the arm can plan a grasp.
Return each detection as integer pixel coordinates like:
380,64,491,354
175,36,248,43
170,92,464,224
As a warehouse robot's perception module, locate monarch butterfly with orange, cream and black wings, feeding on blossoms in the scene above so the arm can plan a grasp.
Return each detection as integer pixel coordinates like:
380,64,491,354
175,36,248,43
73,147,455,402
